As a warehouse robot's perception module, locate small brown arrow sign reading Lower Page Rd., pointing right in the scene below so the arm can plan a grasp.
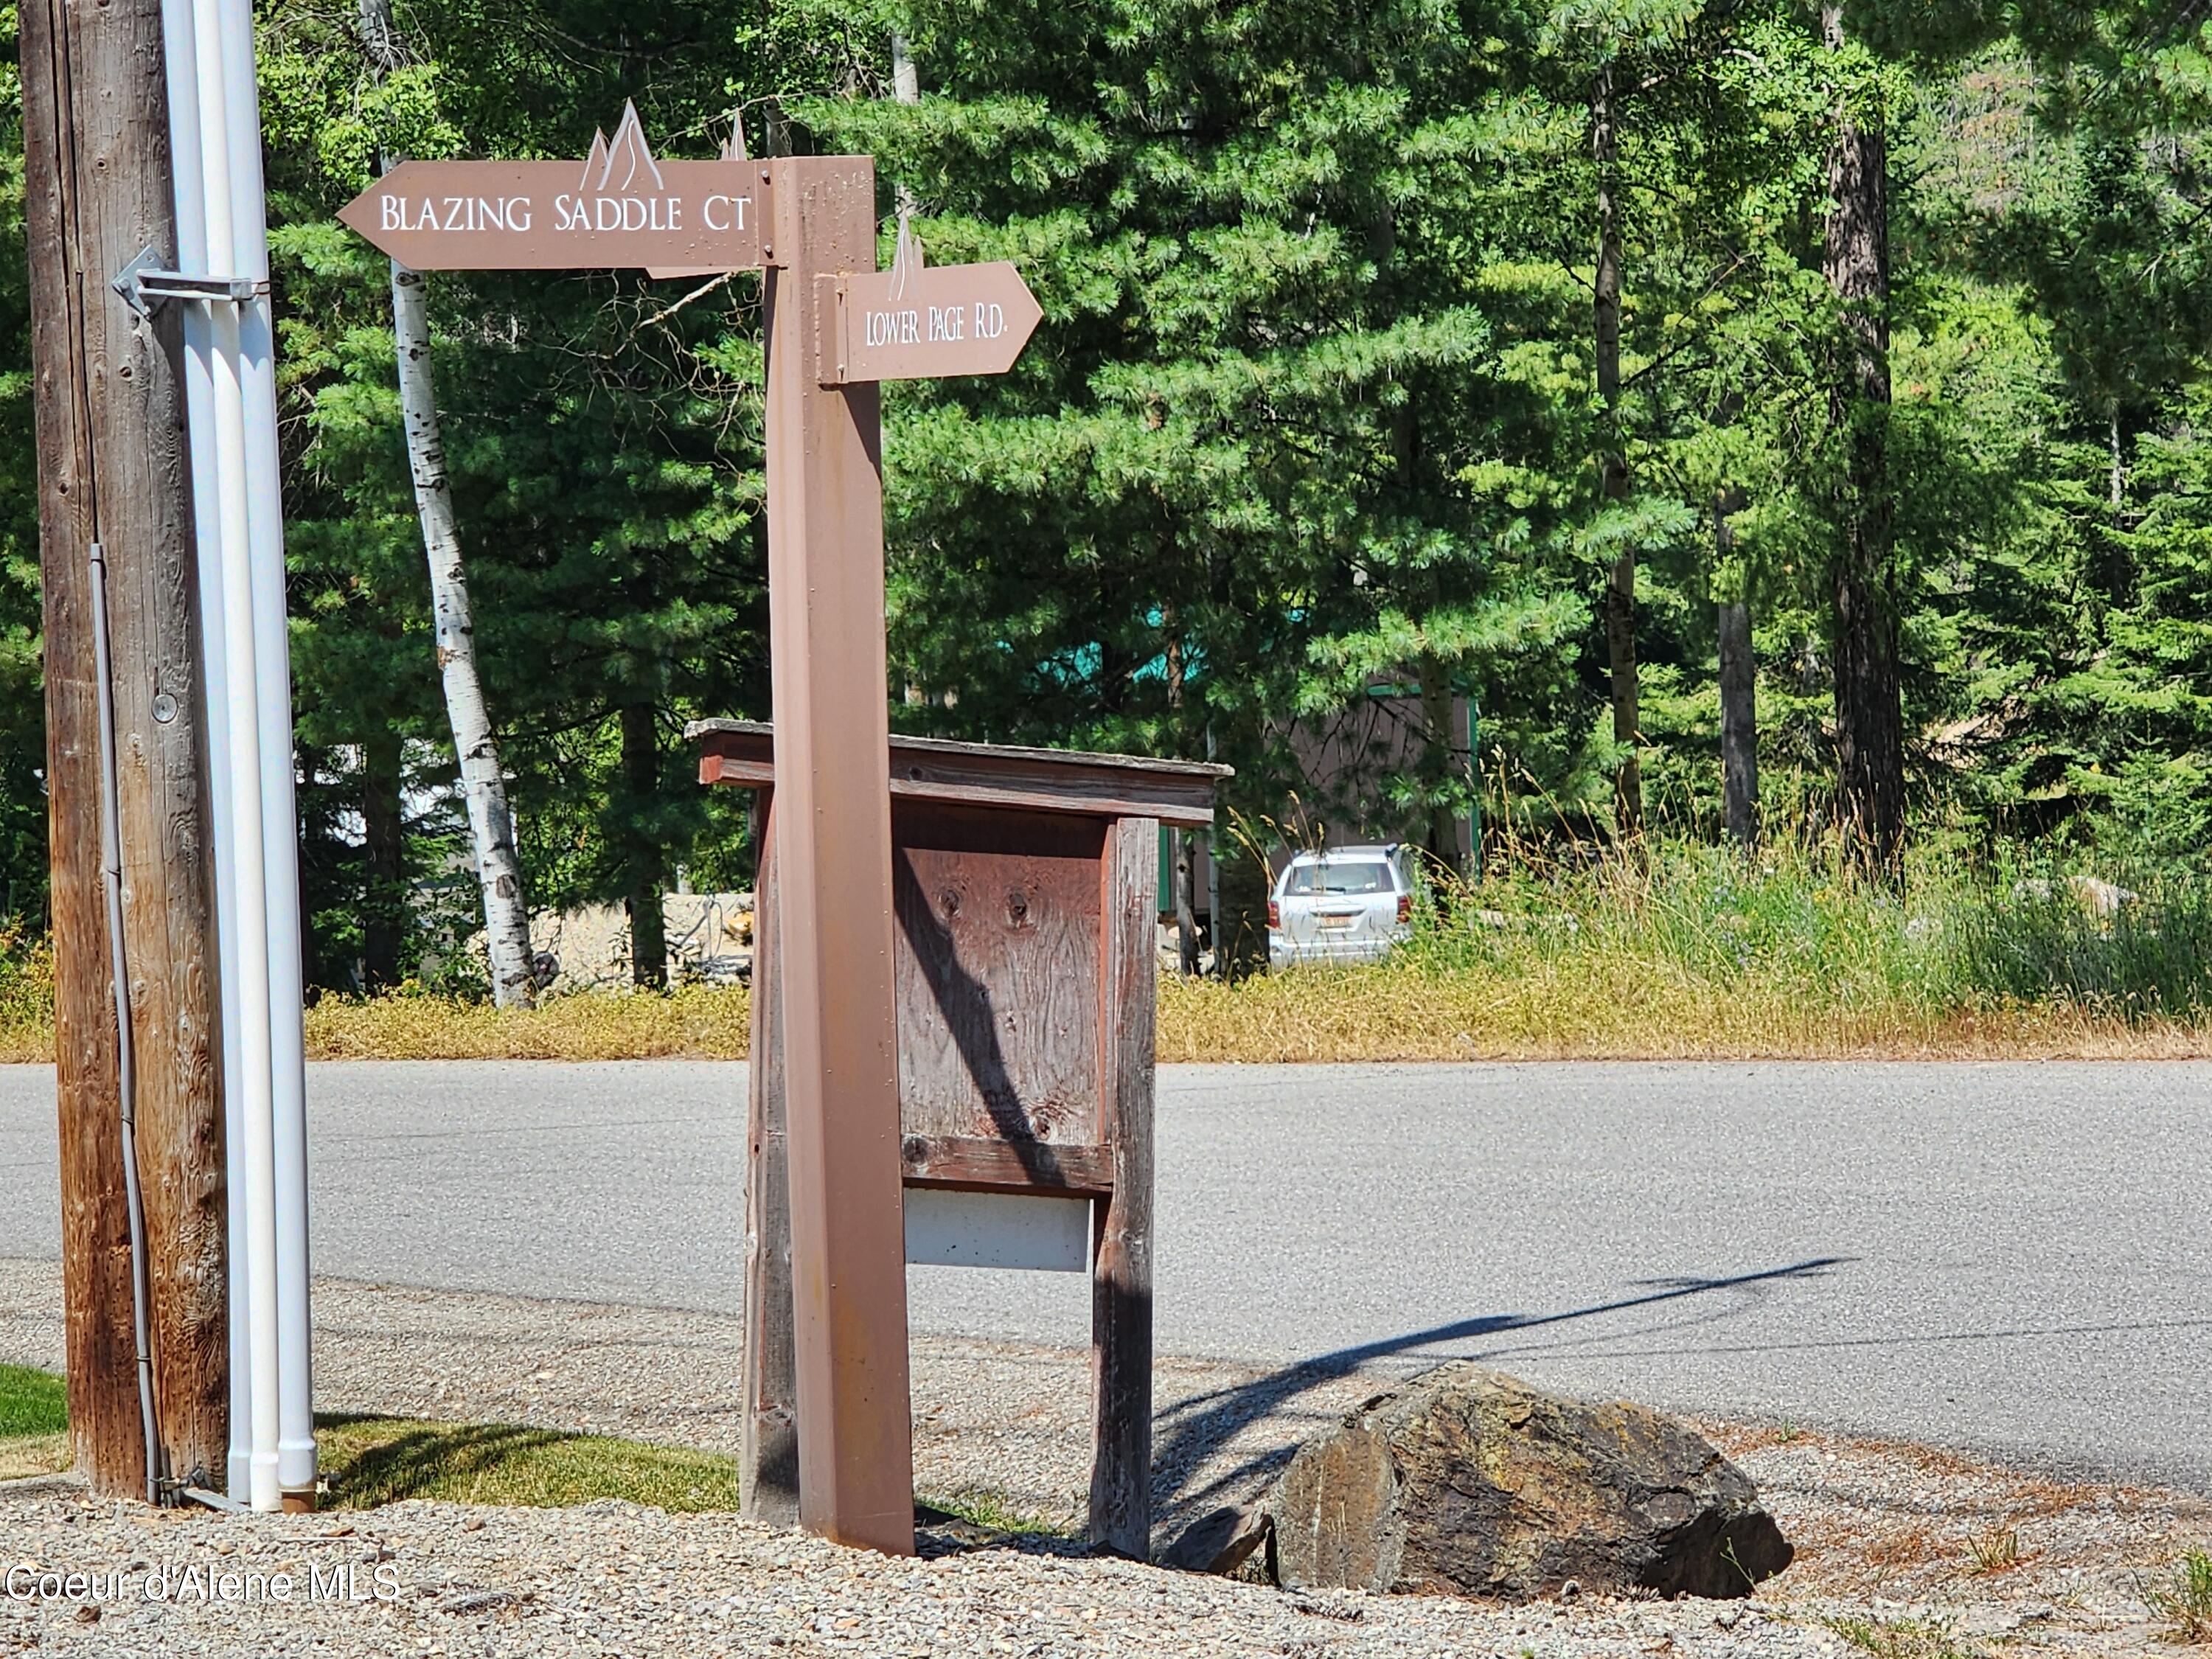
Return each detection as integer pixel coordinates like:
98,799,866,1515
821,257,1044,385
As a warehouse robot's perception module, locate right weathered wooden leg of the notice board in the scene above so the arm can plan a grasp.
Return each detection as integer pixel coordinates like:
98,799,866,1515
1091,818,1159,1562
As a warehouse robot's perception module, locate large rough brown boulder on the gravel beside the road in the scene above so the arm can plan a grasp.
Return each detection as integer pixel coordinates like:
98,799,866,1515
1263,1360,1794,1601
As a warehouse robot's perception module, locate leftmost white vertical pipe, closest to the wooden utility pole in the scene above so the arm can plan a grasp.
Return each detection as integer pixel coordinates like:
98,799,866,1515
161,0,252,1500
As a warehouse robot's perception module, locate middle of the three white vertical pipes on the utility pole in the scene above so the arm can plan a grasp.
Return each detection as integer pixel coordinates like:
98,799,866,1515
192,4,283,1511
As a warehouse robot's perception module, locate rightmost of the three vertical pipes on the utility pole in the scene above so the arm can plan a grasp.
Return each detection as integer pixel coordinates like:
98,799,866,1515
217,0,314,1495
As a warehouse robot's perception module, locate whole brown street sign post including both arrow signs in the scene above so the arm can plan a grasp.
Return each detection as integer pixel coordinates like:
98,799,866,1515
341,119,1037,1555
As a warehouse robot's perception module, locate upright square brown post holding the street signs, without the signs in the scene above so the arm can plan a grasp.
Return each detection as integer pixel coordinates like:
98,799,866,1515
761,155,914,1555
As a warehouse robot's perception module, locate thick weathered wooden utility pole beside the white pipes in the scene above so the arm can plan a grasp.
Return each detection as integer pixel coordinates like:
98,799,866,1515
20,0,228,1495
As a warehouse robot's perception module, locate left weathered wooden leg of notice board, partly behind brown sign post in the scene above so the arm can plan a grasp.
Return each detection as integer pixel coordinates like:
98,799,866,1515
739,790,799,1526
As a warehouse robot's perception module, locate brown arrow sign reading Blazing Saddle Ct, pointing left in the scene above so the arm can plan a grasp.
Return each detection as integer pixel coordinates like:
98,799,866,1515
338,108,770,270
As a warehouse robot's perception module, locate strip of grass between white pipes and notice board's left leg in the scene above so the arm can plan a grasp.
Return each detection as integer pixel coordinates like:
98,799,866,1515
316,1416,737,1513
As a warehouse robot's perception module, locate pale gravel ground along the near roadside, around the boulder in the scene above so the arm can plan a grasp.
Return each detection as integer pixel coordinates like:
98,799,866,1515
0,1259,2212,1659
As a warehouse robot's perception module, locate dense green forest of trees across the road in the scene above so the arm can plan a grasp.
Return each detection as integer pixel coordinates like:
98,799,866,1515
0,0,2212,1026
